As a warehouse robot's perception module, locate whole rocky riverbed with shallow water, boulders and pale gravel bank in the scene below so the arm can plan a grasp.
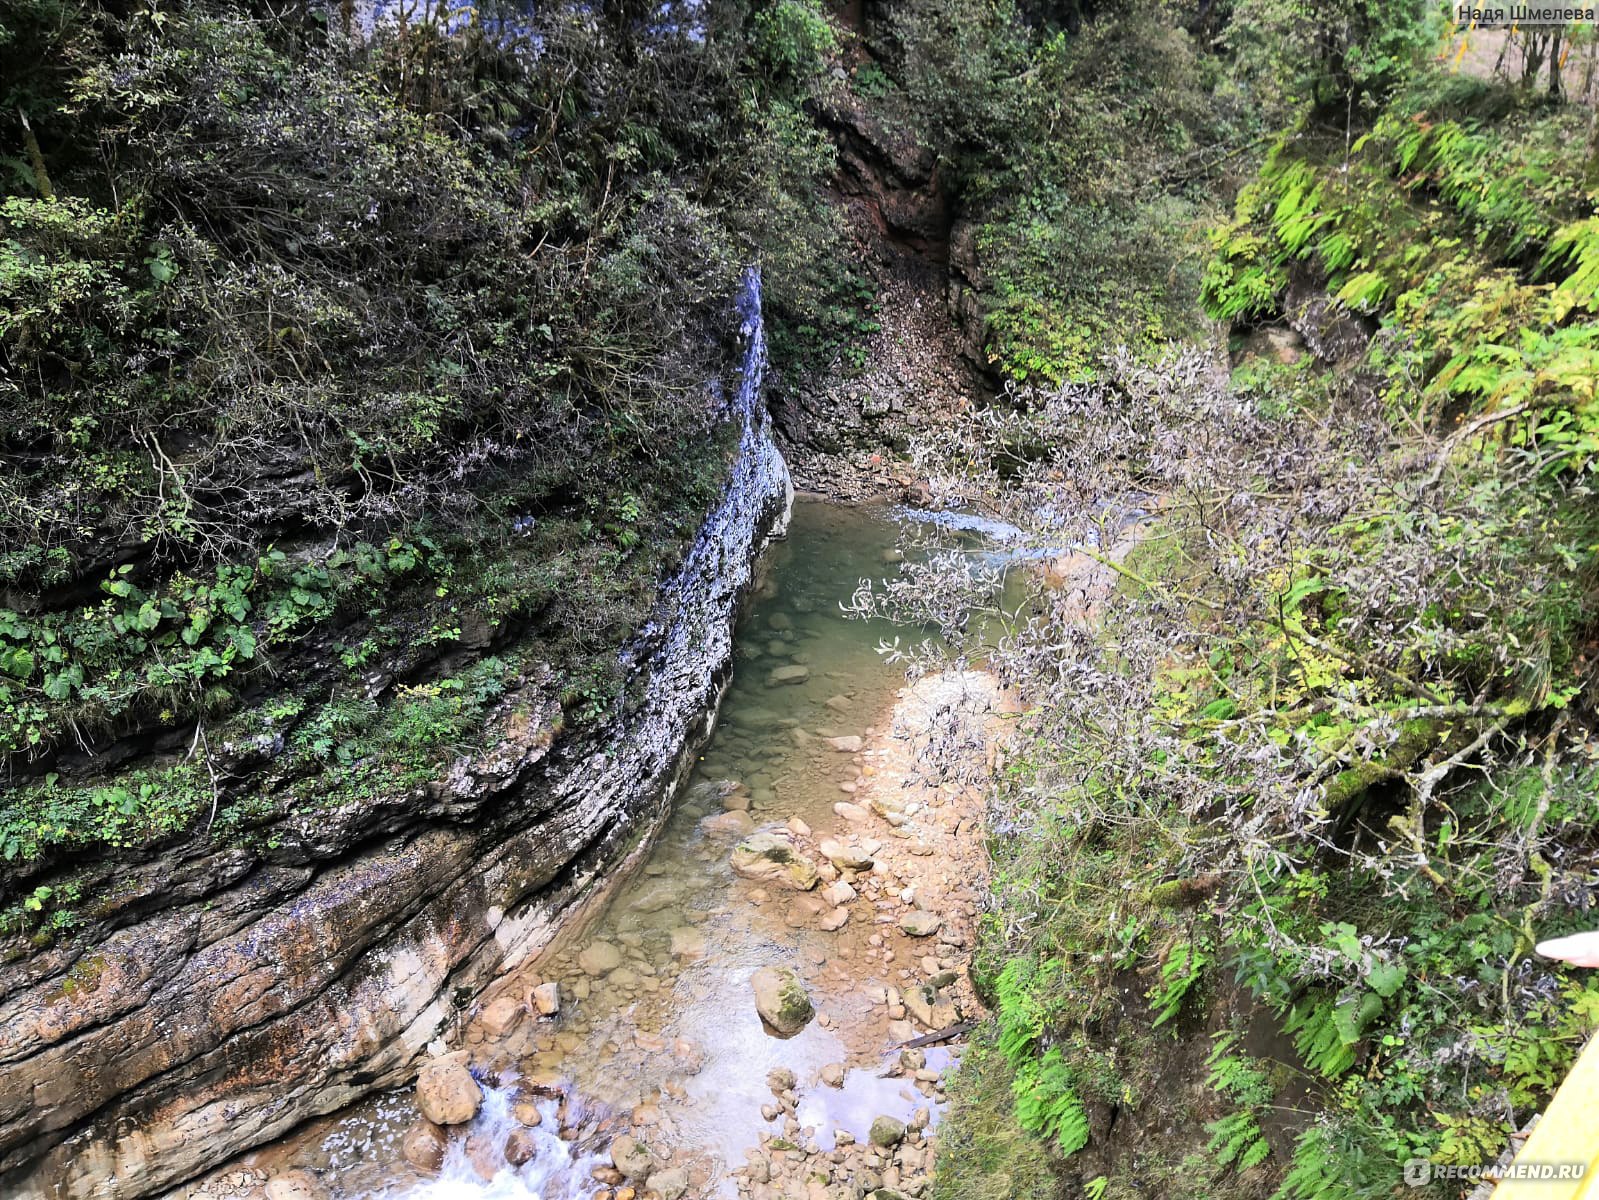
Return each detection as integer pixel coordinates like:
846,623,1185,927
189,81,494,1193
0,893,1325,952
189,506,1003,1200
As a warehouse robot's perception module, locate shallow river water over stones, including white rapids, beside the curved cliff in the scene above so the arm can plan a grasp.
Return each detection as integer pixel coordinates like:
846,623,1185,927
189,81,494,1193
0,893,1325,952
206,501,977,1200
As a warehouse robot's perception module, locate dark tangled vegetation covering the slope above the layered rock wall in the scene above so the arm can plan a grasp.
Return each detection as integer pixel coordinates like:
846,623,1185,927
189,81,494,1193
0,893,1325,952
0,0,852,936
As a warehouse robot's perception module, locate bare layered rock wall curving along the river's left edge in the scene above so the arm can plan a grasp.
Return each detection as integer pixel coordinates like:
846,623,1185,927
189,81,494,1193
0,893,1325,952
0,275,790,1200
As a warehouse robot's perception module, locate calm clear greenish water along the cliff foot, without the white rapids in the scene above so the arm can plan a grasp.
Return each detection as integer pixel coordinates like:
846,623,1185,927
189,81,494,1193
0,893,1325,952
518,502,927,1165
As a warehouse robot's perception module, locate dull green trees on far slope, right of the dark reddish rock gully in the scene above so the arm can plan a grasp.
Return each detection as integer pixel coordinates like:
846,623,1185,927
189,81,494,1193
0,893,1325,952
891,0,1226,384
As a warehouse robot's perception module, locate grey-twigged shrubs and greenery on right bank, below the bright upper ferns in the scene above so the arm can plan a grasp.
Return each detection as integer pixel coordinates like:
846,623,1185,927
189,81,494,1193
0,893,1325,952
914,334,1599,1197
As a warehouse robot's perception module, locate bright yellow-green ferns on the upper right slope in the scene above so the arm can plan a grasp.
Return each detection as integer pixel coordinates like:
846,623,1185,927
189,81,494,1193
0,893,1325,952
1201,84,1599,470
